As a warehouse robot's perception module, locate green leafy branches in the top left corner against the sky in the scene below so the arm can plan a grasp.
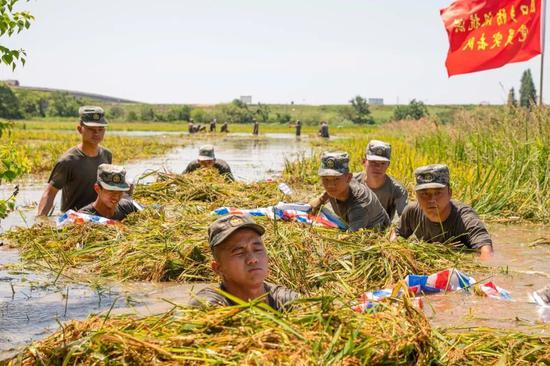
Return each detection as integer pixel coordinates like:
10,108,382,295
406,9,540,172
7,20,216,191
0,0,34,70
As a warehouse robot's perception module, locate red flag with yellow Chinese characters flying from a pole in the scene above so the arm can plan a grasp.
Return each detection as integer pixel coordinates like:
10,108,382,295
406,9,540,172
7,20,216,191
441,0,542,76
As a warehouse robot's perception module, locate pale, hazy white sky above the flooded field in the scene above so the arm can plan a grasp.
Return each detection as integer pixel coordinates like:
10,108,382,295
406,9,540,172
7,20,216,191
0,0,550,104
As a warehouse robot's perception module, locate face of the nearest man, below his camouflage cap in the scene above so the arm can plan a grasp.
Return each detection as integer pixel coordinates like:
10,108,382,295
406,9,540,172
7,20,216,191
212,229,268,288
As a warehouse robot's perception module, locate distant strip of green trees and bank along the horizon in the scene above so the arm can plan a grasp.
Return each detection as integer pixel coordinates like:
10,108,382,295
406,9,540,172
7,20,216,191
0,86,484,127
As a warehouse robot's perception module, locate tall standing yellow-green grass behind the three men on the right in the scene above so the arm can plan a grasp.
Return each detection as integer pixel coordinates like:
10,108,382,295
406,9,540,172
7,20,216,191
287,108,550,221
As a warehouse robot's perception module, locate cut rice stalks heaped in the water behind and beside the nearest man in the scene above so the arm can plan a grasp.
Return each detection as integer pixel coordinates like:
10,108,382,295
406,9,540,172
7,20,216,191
4,170,480,290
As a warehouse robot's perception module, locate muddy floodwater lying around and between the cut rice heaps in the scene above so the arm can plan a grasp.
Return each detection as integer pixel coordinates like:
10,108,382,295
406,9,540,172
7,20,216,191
0,134,550,360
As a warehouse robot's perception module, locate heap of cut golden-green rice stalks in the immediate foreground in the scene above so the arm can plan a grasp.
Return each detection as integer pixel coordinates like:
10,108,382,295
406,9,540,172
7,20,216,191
4,298,435,365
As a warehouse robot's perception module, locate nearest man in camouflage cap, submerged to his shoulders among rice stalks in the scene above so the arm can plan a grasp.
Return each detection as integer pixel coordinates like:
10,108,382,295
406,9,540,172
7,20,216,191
190,215,299,311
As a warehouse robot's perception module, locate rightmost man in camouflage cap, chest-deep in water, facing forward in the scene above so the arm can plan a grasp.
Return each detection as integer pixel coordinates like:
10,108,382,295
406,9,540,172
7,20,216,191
392,164,493,259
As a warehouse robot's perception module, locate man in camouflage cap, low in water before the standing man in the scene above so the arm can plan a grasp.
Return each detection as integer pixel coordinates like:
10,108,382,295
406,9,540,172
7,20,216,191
78,164,139,221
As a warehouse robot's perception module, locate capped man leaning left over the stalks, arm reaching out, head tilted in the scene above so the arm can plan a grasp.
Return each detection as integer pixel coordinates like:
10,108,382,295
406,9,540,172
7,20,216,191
309,152,390,231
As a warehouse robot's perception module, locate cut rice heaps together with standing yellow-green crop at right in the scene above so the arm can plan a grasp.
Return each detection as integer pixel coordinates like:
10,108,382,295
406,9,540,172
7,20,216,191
3,110,550,365
